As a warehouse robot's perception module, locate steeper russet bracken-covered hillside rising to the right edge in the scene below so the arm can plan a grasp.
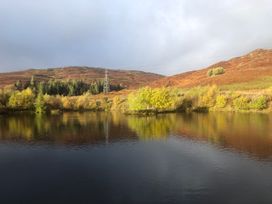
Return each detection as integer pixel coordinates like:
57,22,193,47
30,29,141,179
151,49,272,88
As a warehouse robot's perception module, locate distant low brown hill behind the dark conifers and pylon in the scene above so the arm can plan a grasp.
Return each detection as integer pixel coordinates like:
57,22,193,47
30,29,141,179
0,67,163,88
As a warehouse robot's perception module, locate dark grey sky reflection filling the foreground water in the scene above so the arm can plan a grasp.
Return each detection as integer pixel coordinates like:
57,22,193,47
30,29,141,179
0,134,272,203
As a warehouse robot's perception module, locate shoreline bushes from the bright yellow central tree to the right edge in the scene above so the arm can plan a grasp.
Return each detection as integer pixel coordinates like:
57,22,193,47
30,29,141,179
125,86,272,113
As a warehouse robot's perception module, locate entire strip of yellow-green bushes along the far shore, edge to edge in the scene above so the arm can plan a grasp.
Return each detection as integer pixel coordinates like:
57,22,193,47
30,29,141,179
0,81,272,114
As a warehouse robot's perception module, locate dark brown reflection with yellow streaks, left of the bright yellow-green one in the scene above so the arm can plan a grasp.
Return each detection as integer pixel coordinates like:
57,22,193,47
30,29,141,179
0,113,135,144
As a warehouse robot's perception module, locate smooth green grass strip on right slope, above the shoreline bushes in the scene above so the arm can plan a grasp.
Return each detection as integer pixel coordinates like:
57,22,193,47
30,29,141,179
220,77,272,91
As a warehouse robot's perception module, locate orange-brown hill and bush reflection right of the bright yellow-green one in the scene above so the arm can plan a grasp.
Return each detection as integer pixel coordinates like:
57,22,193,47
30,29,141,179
176,113,272,158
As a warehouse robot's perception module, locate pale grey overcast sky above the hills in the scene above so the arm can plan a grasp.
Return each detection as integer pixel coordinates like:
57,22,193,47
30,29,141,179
0,0,272,75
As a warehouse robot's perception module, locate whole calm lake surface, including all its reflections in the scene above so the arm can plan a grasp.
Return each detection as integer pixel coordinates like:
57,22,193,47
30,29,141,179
0,113,272,204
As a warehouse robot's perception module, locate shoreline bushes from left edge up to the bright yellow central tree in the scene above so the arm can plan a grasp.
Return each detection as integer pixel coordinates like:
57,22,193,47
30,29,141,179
0,89,129,113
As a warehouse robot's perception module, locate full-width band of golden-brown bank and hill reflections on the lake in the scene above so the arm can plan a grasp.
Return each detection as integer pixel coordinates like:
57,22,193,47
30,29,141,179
0,113,272,158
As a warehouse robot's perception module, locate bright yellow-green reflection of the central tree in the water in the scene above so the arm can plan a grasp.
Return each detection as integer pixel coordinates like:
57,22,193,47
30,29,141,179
128,114,177,140
